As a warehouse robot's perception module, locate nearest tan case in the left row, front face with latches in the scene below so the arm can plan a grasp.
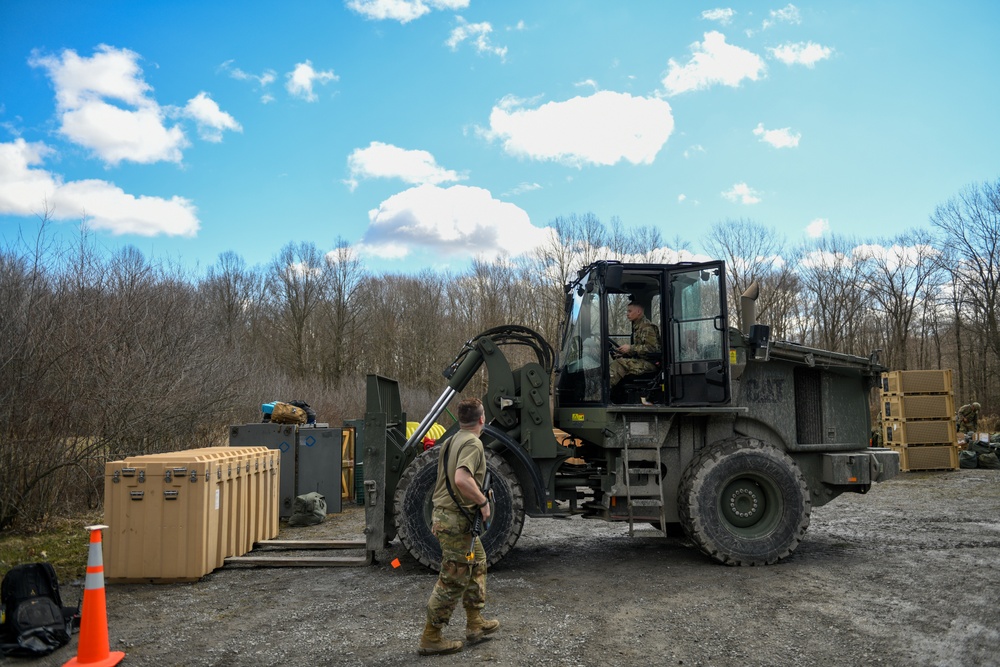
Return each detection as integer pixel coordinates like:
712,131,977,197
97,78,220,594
103,455,222,582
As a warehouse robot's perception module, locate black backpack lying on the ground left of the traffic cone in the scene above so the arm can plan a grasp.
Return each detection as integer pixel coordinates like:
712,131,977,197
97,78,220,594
0,563,80,657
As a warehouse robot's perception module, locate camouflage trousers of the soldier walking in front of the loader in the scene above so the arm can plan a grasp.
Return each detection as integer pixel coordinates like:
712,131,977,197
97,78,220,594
427,508,486,628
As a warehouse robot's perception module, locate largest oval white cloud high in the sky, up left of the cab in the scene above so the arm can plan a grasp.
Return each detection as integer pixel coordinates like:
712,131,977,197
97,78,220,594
483,91,674,167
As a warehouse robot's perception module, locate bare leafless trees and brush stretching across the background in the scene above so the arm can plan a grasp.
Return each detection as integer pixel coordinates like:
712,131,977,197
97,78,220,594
0,181,1000,530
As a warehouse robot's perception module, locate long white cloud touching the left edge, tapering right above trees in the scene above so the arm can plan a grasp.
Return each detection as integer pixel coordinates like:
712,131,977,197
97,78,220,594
0,139,200,236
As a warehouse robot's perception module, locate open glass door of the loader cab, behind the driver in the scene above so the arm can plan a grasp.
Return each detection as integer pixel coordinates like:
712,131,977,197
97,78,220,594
666,262,730,405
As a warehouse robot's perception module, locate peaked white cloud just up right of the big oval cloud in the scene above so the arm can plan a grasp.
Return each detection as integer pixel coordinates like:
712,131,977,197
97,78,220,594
663,30,767,95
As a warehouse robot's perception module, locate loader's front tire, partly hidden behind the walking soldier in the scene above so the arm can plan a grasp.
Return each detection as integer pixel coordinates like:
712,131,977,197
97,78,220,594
394,446,524,571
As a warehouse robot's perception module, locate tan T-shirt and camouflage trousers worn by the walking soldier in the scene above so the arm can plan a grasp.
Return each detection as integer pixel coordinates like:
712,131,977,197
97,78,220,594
427,431,486,628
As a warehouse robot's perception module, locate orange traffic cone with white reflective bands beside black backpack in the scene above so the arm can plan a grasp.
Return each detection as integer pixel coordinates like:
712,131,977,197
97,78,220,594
63,526,125,667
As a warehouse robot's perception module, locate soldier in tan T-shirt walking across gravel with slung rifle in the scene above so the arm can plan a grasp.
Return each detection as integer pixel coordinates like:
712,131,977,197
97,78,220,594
418,398,500,655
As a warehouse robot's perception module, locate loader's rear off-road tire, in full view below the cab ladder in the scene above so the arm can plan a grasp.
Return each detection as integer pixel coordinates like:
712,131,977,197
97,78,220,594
677,438,812,565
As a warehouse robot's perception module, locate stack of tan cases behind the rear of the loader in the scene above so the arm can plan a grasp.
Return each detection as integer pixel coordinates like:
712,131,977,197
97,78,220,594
882,370,958,472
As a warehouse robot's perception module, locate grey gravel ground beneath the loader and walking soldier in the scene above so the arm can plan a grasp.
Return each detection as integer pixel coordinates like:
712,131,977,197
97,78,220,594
15,469,1000,667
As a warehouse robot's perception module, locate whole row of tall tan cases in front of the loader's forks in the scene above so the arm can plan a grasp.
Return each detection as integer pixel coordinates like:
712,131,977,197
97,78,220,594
103,447,280,582
